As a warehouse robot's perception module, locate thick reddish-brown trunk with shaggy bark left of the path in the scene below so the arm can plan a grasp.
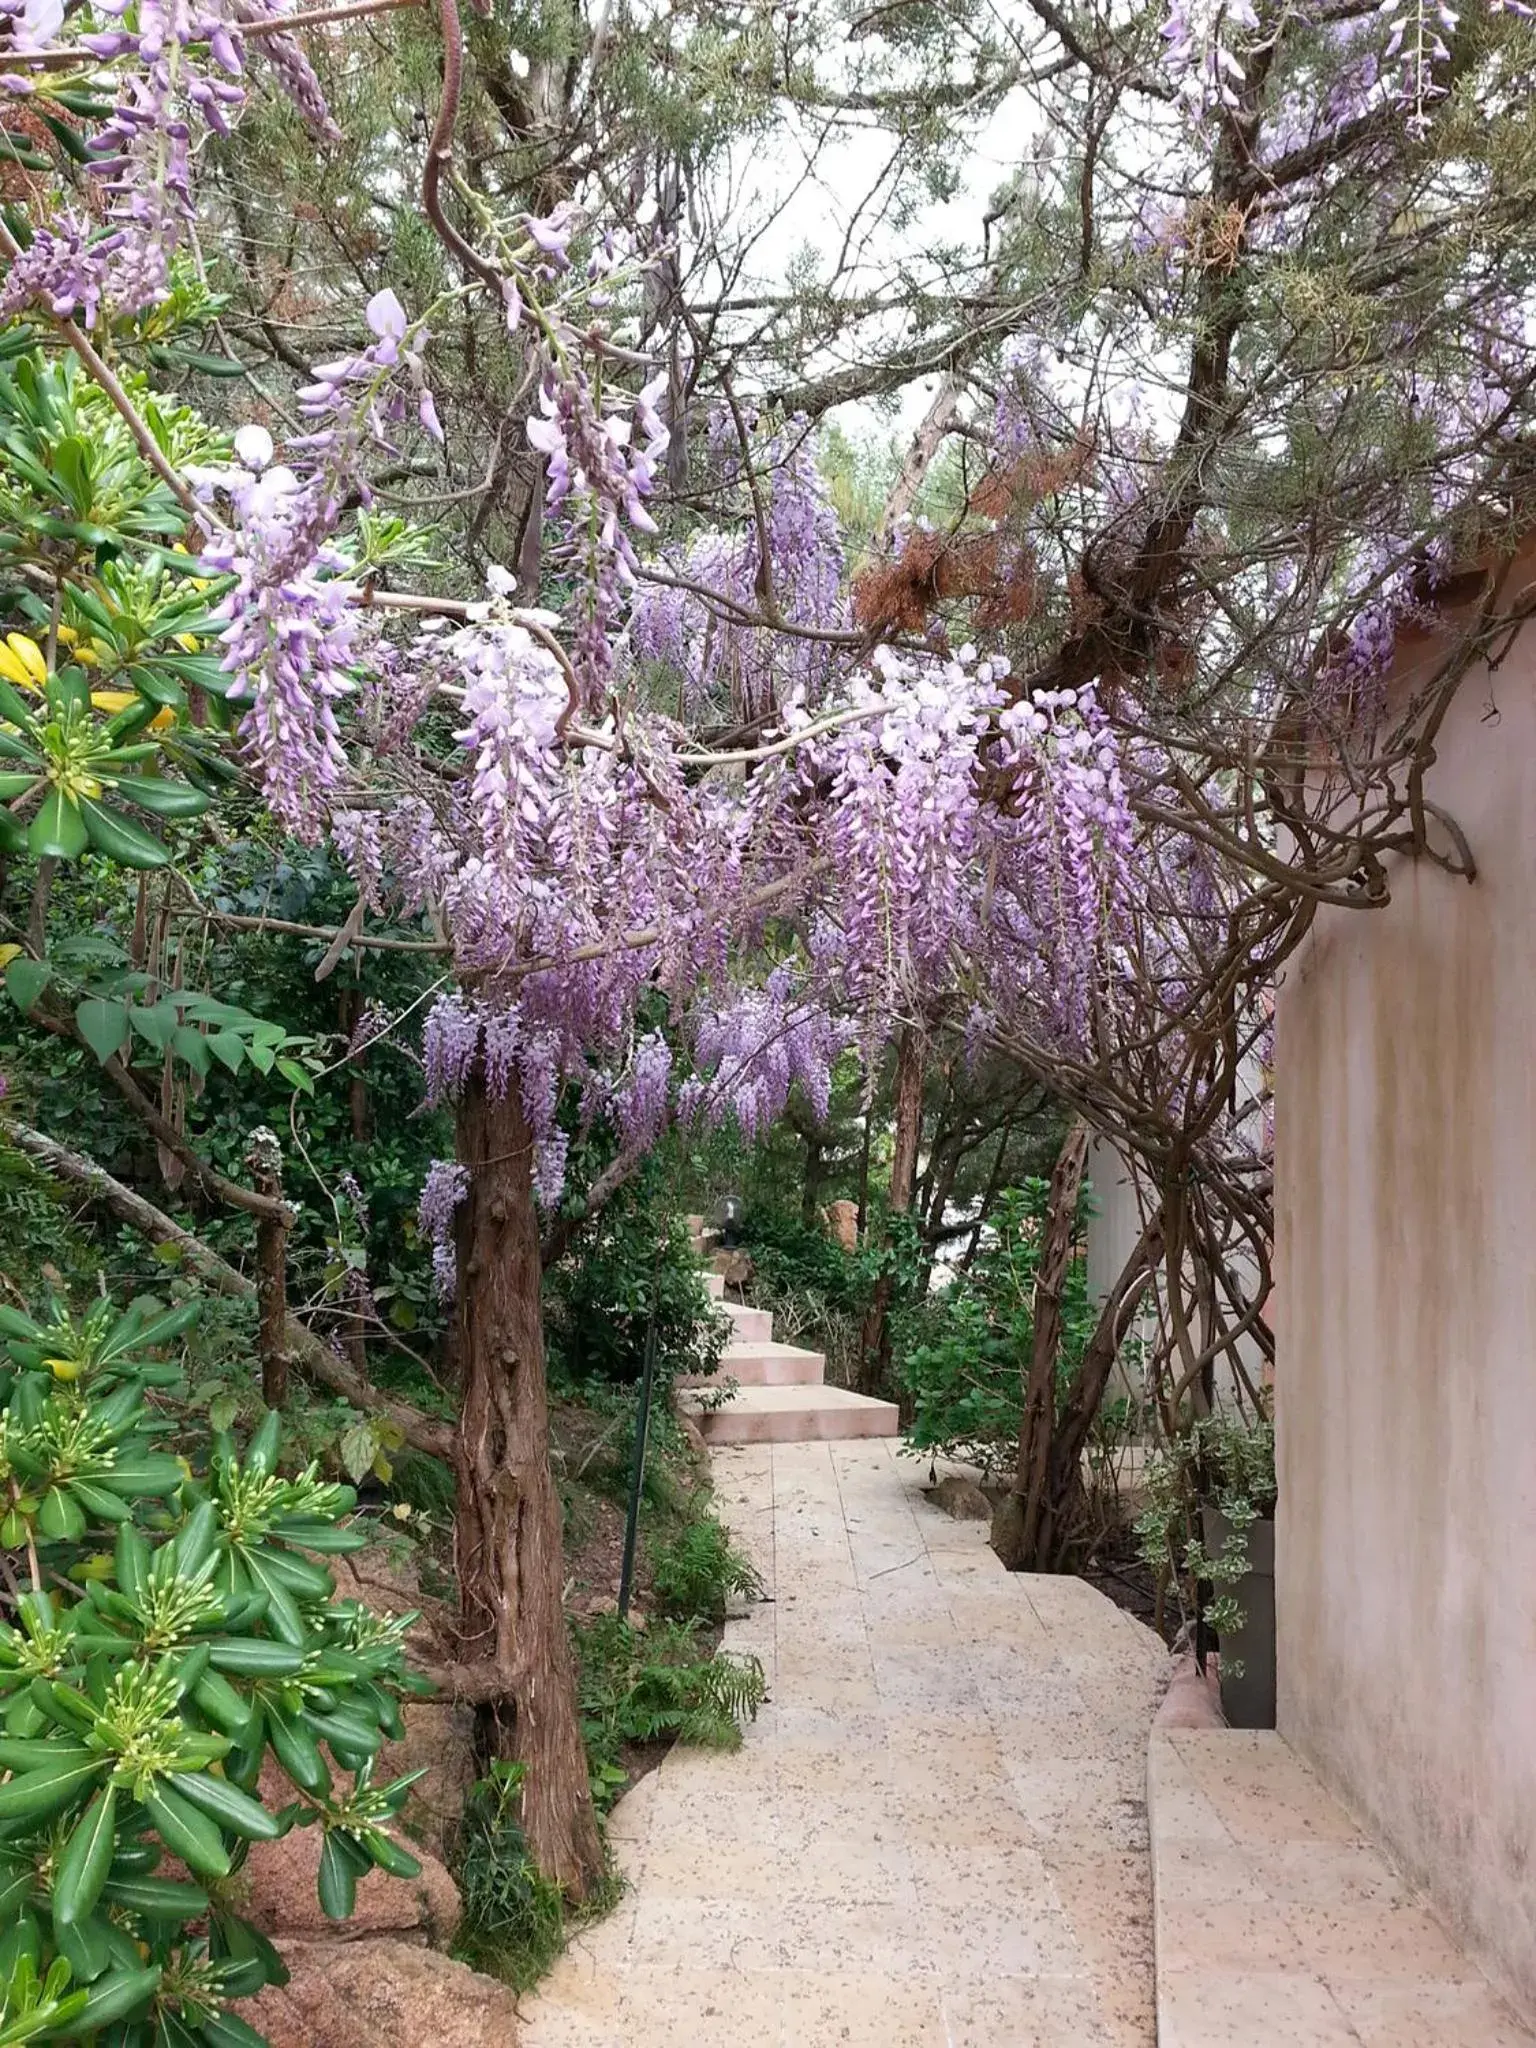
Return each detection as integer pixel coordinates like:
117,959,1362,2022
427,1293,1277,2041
455,1069,602,1898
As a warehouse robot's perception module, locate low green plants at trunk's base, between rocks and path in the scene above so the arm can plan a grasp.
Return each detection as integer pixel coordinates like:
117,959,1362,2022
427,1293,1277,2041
451,1761,565,1991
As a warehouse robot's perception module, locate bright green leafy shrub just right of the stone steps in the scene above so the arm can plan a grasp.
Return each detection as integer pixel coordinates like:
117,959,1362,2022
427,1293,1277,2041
897,1180,1096,1473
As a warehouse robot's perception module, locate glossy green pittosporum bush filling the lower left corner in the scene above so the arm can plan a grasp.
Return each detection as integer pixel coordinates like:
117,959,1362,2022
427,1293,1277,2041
0,1300,420,2048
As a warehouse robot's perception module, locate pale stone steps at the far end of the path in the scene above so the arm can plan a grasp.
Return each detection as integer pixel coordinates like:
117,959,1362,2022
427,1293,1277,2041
678,1217,899,1444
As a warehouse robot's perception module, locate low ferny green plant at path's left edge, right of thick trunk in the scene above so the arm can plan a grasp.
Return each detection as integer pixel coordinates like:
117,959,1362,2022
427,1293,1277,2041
575,1614,768,1808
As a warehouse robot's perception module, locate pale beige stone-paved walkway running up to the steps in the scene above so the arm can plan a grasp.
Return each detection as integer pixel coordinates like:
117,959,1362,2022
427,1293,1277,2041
522,1442,1167,2048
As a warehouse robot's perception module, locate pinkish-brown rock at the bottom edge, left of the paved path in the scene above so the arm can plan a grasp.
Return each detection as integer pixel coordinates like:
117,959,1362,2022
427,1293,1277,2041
238,1939,518,2048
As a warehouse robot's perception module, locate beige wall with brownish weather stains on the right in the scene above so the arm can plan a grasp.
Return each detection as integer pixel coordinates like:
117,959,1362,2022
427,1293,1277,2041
1276,598,1536,2011
